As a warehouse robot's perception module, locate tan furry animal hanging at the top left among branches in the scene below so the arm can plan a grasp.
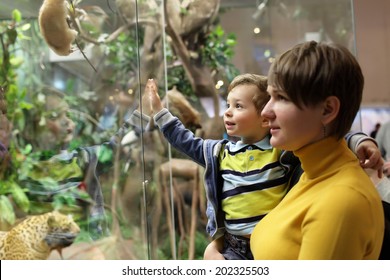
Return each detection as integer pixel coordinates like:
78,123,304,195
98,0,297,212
38,0,78,56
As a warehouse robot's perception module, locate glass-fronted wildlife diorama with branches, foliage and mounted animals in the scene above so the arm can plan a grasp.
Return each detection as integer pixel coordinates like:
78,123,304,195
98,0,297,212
0,0,390,260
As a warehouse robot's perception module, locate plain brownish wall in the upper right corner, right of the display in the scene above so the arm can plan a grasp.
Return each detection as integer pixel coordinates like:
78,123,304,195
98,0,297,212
354,0,390,107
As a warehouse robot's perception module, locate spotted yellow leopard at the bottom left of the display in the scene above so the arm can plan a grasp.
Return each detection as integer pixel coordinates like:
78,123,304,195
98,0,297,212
0,211,80,260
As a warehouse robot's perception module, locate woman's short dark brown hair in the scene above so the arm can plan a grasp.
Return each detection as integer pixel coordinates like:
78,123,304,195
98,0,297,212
268,41,364,138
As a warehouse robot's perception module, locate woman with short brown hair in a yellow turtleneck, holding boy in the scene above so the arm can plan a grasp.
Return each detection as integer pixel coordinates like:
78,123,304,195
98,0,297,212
251,41,384,260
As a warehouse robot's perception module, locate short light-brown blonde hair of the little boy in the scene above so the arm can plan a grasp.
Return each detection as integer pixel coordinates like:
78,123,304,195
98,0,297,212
228,73,269,114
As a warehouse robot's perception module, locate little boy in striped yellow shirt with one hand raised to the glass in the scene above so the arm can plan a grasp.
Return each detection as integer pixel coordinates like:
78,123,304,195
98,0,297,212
141,74,380,259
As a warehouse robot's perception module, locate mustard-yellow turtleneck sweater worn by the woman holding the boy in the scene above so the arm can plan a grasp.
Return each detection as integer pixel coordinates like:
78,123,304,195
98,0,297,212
251,137,384,260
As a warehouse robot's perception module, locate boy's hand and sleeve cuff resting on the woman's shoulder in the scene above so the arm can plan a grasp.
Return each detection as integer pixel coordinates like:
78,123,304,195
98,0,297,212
345,132,383,178
